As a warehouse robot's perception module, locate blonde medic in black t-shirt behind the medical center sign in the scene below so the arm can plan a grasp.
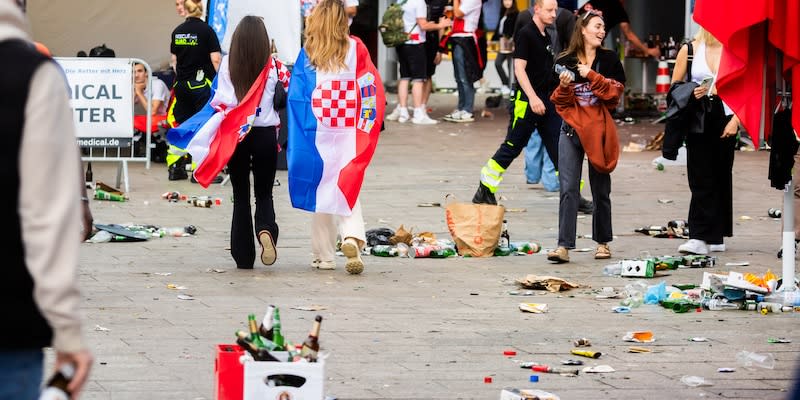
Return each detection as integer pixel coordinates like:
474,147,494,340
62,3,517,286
167,0,222,180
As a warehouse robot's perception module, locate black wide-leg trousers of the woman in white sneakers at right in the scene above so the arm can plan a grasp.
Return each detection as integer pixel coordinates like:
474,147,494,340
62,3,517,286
686,97,736,244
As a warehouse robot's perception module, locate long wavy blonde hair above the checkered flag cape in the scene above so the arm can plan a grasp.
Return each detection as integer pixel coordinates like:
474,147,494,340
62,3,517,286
305,0,350,72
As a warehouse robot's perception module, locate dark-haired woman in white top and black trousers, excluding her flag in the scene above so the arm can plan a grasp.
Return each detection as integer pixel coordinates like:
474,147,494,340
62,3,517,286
217,16,289,269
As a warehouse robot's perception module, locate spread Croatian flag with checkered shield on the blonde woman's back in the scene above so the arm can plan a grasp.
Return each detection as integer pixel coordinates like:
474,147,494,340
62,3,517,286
286,37,386,216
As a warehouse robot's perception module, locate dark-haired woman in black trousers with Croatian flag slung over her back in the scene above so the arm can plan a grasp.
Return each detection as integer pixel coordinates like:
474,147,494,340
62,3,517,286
168,16,289,269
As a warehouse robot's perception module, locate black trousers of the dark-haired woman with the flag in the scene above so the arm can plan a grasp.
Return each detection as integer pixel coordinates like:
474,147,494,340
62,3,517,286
228,126,278,268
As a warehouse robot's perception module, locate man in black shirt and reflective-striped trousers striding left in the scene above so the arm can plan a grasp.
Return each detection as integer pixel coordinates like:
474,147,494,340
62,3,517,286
472,0,561,204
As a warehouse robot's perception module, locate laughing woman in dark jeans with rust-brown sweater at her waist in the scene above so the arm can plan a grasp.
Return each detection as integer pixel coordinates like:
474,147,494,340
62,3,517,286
547,10,625,263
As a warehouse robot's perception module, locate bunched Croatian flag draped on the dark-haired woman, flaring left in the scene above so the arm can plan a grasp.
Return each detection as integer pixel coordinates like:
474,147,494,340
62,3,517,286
167,58,272,188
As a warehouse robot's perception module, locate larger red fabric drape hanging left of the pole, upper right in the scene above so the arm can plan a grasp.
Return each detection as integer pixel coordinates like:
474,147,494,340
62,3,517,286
694,0,774,147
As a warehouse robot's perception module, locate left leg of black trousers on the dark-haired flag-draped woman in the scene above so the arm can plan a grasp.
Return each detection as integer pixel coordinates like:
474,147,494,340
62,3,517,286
228,135,256,269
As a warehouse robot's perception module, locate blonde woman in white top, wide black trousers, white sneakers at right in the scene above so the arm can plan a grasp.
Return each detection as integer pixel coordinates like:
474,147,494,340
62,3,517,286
672,28,739,254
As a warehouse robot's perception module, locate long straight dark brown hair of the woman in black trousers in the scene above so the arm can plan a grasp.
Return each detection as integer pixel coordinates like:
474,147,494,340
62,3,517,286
228,15,270,101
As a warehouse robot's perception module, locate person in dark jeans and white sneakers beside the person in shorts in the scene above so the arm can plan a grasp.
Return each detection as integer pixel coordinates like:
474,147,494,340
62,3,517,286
444,0,486,122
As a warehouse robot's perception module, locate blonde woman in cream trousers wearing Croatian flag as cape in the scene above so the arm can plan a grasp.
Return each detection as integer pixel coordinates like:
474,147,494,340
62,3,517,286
286,0,385,274
